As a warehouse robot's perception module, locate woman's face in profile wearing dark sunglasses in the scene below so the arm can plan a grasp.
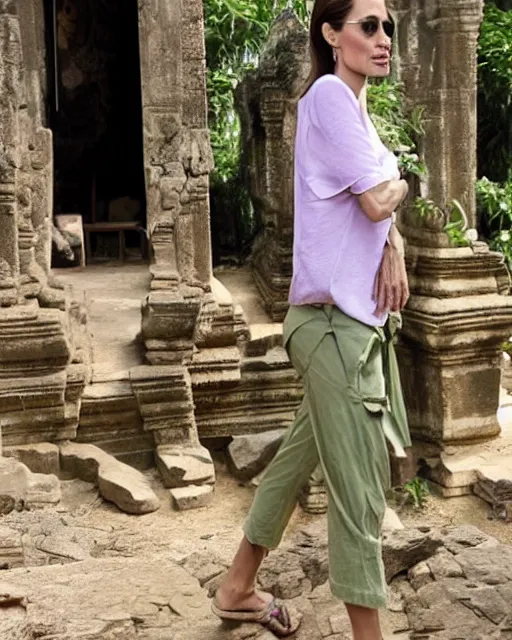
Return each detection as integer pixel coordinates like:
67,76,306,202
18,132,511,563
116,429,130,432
324,0,391,78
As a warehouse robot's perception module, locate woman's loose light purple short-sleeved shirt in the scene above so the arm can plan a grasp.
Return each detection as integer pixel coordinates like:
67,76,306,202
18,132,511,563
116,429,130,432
289,74,399,326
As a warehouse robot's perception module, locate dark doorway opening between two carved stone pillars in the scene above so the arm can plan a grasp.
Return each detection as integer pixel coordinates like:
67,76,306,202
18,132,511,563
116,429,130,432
45,0,146,259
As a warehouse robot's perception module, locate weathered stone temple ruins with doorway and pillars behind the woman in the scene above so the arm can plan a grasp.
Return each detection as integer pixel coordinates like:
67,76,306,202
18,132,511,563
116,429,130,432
0,0,512,510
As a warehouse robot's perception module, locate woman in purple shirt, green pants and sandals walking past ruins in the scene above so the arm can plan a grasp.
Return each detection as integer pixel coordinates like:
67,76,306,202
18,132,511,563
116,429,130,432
213,0,410,640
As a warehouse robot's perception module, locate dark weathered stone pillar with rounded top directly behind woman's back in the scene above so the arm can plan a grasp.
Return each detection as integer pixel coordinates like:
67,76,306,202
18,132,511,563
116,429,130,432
237,11,309,321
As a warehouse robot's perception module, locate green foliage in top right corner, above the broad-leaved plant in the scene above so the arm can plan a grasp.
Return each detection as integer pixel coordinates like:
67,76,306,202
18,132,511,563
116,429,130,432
478,2,512,182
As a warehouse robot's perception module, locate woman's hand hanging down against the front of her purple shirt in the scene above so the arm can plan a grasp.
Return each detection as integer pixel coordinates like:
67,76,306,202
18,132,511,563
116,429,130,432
373,238,409,317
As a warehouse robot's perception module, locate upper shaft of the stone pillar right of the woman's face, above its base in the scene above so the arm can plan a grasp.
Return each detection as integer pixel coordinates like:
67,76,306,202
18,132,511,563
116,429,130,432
390,0,483,227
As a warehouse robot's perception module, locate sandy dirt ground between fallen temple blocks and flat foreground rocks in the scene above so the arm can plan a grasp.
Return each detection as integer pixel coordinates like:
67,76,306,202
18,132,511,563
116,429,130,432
47,463,512,562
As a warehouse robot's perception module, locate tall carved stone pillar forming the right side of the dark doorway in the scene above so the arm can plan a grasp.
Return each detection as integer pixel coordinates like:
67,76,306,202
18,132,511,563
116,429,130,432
136,0,226,486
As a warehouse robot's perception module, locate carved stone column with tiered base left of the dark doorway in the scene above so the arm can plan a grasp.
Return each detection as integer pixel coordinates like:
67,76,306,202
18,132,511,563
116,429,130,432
0,0,88,449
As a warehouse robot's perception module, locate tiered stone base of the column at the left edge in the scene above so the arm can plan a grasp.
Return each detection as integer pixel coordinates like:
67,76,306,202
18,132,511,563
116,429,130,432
0,300,89,446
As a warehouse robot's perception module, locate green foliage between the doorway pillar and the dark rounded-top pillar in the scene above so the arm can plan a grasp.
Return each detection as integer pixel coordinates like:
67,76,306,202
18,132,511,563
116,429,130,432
204,0,307,264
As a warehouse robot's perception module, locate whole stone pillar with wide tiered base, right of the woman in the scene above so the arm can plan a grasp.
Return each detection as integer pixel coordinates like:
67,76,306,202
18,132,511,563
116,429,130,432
391,0,512,448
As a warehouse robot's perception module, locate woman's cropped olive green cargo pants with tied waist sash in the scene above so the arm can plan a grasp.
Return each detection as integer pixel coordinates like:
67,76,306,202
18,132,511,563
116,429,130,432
244,305,410,609
